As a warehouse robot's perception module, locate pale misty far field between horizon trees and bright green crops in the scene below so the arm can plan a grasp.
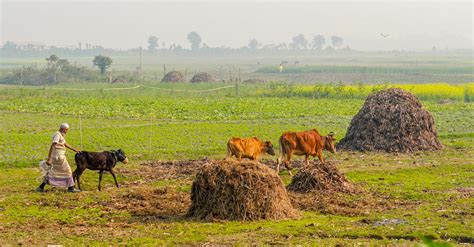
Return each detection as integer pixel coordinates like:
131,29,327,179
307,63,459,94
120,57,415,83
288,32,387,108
0,51,474,84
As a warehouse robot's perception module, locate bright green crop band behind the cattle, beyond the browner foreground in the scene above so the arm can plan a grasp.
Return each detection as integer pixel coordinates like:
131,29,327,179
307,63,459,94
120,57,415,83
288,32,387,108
0,91,474,167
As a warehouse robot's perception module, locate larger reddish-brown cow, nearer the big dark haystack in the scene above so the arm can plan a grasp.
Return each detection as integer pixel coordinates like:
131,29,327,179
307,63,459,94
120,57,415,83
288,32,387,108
277,129,336,175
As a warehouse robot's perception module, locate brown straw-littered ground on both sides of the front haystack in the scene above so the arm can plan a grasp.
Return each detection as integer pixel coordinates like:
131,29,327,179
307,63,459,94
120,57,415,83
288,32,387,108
112,159,417,219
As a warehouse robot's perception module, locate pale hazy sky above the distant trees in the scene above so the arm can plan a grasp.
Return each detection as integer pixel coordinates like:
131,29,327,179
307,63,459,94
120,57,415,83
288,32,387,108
0,0,474,50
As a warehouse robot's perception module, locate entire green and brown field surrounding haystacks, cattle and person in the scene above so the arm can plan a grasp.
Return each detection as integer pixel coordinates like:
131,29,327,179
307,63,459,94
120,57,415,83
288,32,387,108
0,83,474,245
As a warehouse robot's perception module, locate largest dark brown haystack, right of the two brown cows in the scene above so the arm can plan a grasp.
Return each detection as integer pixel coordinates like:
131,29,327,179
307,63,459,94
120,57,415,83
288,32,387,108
337,88,443,152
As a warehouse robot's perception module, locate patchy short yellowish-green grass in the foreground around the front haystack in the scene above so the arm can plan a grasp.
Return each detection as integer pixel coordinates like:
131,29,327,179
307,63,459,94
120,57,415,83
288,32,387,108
0,143,474,245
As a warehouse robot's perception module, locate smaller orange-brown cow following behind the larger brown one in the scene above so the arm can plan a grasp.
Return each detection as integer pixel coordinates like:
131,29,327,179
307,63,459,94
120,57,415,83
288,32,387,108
226,137,275,161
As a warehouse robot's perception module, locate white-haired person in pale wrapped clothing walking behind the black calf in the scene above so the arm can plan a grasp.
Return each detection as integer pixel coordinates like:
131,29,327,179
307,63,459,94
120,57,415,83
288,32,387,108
36,123,80,192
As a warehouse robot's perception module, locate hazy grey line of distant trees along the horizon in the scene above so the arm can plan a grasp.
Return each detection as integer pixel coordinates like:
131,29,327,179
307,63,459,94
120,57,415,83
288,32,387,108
0,31,350,57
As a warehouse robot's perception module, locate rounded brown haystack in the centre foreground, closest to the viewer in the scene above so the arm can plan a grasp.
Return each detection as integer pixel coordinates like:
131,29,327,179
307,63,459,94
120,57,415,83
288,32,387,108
188,161,299,220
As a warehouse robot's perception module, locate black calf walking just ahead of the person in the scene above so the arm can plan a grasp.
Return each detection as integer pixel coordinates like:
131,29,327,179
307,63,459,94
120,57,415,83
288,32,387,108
73,149,128,191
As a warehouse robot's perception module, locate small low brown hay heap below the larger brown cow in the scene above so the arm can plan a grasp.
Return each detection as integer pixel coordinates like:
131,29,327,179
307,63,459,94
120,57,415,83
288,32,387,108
287,161,355,193
